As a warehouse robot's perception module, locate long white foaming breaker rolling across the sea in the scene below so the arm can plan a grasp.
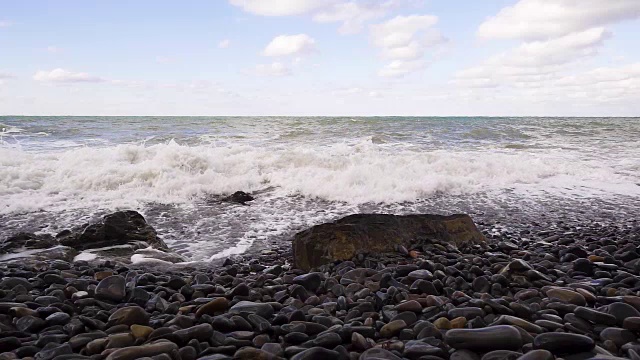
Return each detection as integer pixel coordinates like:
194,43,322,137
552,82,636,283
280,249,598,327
0,141,640,214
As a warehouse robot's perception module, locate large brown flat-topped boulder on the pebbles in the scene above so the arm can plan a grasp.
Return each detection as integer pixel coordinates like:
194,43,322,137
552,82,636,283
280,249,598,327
293,214,484,270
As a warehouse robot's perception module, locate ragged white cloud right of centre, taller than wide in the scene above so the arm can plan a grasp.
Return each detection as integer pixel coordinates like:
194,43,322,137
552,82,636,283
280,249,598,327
371,15,447,77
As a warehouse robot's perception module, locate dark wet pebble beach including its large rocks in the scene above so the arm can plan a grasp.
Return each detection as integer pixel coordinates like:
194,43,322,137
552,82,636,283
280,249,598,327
0,205,640,360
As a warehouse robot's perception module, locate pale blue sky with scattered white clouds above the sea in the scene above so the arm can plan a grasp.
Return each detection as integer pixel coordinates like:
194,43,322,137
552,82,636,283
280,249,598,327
0,0,640,116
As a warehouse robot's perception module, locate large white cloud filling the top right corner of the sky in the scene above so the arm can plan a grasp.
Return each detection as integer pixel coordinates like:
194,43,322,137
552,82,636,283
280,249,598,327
477,0,640,40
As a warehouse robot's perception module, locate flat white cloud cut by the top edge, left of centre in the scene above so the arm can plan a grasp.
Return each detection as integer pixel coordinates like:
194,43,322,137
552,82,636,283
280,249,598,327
229,0,335,16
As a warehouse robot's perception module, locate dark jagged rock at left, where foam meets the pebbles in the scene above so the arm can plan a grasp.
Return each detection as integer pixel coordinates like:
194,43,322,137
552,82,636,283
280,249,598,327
59,210,167,250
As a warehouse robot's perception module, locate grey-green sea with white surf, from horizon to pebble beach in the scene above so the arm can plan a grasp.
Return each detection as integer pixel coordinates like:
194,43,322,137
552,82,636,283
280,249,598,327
0,116,640,261
